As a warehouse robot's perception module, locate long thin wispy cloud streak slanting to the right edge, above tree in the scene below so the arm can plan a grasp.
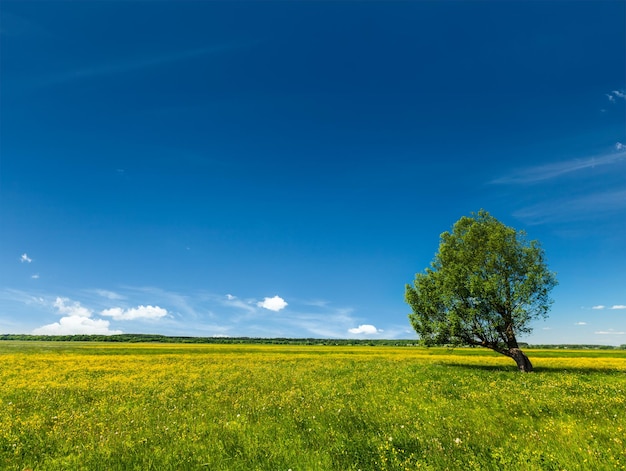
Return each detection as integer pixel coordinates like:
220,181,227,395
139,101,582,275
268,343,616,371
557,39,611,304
491,149,626,184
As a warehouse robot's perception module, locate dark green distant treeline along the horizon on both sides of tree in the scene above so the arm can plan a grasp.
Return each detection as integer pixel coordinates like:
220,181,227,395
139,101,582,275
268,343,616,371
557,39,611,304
0,334,626,350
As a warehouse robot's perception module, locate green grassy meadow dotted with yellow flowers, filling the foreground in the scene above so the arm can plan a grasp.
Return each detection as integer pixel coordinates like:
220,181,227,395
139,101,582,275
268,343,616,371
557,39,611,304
0,341,626,471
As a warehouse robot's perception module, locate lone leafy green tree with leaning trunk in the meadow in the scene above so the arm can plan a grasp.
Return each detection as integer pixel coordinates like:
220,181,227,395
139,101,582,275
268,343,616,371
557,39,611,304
405,210,557,372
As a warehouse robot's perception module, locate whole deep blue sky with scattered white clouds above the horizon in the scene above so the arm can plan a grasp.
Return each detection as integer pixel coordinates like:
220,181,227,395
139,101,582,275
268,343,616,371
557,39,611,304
0,0,626,345
